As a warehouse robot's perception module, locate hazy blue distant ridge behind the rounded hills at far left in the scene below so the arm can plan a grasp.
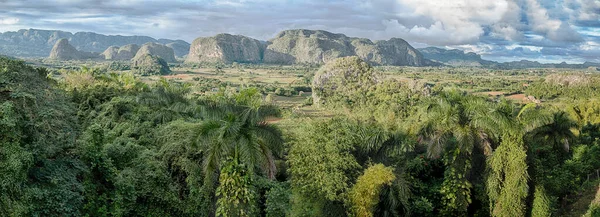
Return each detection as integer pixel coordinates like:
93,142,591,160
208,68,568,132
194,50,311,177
0,29,189,57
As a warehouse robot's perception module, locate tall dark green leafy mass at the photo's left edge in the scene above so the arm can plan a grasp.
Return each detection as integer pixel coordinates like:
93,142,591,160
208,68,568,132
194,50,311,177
0,58,83,216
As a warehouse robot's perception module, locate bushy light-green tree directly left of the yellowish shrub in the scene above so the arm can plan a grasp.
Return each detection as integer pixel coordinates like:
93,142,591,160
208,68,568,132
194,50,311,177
288,118,361,216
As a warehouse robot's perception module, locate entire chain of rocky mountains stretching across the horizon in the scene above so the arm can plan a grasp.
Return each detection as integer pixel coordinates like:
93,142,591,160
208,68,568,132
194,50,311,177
0,29,600,69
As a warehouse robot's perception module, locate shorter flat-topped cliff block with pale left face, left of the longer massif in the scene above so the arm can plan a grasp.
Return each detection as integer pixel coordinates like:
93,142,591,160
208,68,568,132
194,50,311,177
185,34,264,63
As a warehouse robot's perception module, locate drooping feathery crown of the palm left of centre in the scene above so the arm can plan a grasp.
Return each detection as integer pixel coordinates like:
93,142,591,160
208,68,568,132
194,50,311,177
197,88,283,179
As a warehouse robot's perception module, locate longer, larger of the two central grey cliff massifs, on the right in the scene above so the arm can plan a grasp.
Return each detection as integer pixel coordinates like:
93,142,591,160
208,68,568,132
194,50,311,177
263,29,427,66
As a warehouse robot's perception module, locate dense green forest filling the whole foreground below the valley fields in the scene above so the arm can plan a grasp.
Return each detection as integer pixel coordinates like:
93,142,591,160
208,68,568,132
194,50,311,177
0,57,600,217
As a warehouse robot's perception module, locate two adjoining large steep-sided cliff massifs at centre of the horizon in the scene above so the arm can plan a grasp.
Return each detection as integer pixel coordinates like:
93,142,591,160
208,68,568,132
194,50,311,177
186,29,437,66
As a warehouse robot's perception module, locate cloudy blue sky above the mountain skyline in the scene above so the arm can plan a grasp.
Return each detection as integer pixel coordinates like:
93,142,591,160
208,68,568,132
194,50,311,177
0,0,600,63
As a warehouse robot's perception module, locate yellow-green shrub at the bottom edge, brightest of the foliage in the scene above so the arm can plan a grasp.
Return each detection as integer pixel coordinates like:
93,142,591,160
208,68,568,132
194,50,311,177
348,164,396,217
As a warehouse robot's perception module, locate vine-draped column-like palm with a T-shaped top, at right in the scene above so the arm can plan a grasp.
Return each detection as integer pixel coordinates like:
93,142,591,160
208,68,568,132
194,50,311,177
477,100,545,216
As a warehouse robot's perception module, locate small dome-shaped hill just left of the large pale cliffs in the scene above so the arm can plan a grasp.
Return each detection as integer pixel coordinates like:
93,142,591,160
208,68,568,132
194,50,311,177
131,54,171,75
